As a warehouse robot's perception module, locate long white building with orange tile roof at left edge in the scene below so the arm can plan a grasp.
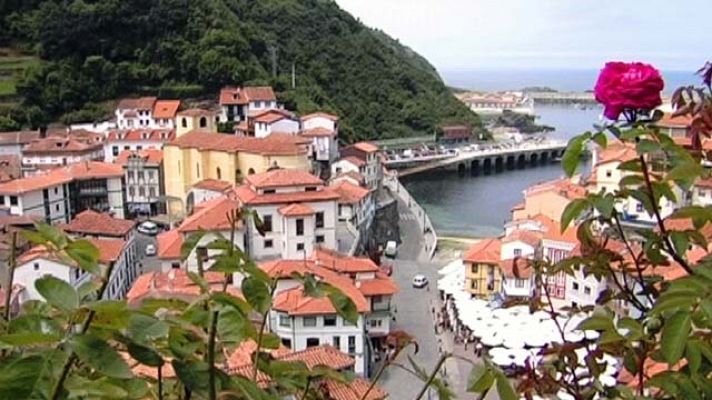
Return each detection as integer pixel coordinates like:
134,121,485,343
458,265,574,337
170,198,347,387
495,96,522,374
0,161,126,224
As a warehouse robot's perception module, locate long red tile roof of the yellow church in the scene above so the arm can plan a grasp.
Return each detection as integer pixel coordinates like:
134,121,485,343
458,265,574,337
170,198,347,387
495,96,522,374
169,130,307,155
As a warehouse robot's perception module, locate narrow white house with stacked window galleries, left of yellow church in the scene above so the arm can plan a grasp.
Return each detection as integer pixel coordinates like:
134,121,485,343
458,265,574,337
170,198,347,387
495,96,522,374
116,149,166,216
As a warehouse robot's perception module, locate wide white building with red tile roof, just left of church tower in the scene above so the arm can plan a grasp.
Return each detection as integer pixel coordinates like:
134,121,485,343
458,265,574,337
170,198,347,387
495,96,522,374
104,129,175,162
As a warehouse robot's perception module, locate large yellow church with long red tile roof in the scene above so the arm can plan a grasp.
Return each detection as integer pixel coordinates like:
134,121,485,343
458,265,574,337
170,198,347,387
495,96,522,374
163,130,310,215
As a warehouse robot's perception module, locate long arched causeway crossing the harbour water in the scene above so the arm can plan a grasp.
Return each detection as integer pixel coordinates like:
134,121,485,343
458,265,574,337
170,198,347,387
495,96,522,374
385,140,566,177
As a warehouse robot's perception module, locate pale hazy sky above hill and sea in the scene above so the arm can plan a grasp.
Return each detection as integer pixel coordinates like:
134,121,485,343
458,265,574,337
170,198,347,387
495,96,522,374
336,0,712,71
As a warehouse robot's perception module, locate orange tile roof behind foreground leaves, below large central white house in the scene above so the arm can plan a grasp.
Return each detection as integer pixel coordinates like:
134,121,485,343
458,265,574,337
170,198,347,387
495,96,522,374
126,269,242,304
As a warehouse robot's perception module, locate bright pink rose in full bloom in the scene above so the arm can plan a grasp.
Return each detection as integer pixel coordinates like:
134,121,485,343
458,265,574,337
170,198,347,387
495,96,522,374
594,62,665,120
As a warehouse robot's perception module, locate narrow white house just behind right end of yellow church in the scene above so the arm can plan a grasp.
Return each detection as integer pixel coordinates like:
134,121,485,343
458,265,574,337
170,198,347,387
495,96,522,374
301,112,339,163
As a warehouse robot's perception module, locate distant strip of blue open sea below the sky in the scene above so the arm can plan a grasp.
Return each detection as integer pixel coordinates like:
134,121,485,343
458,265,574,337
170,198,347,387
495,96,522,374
439,68,700,94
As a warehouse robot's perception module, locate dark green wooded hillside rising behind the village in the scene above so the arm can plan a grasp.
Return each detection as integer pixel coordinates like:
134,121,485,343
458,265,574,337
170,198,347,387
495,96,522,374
0,0,480,140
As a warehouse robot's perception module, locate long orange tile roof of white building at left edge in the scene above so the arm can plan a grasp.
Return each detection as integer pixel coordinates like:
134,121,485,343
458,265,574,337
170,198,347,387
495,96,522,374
0,161,124,194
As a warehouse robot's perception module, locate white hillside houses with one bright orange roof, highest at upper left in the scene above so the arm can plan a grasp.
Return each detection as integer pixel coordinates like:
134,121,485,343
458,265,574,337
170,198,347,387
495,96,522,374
114,97,180,129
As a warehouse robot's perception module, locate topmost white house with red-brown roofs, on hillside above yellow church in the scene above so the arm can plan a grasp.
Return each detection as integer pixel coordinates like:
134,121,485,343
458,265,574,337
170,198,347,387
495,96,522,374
219,86,278,122
